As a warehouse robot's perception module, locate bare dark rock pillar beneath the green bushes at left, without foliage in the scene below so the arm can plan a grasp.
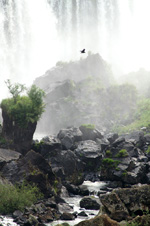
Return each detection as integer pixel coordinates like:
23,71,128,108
2,110,37,155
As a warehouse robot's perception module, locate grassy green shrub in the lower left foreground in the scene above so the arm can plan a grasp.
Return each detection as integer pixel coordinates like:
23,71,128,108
0,183,43,214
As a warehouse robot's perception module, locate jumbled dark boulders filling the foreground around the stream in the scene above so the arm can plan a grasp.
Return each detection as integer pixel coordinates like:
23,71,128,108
0,125,150,226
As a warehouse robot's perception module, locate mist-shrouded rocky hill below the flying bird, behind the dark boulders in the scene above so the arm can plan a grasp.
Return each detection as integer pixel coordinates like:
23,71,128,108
35,54,137,134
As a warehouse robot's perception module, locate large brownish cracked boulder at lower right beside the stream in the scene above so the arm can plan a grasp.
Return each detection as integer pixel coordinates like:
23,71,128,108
100,185,150,221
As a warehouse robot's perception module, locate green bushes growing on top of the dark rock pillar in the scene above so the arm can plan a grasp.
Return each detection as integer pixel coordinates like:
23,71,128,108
1,80,45,127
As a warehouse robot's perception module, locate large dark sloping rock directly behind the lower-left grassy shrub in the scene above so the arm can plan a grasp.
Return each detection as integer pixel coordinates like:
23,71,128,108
1,151,59,196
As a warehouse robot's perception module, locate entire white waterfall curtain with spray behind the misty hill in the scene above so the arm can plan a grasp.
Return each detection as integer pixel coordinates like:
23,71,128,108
0,0,150,98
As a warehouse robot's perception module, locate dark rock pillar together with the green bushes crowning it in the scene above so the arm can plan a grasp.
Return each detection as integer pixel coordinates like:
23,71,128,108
1,80,45,154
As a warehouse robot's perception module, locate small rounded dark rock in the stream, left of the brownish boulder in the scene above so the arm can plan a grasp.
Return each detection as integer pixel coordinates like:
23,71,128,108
80,197,100,210
